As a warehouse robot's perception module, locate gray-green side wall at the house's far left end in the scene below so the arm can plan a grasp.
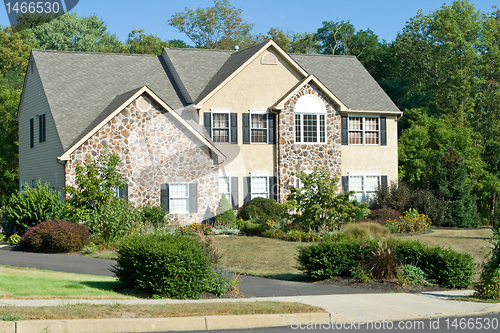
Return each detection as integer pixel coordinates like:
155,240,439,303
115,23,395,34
18,57,64,190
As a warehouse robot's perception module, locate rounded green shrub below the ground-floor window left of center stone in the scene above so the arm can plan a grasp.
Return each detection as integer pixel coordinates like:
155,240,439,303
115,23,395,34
238,198,283,221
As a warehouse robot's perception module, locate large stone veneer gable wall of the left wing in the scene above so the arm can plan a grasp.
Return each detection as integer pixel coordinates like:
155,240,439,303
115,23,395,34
66,92,219,224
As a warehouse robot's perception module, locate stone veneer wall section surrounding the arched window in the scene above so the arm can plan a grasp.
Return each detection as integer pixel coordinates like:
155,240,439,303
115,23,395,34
277,84,342,203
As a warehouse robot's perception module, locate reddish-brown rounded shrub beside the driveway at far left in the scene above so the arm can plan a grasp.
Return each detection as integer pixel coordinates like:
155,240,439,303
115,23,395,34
19,221,90,253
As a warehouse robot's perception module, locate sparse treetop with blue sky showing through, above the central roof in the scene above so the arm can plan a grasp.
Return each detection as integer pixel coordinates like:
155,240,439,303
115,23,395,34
168,0,253,50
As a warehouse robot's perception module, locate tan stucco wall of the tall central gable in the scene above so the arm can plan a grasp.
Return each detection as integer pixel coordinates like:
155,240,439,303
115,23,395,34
199,50,302,205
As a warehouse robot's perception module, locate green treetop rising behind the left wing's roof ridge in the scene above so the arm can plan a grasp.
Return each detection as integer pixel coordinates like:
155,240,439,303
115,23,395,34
31,13,126,53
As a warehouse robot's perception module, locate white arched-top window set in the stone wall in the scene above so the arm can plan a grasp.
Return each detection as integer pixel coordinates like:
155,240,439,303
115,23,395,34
295,95,326,143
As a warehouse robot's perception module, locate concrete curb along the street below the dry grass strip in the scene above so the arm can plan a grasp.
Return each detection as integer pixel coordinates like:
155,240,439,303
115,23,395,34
0,312,336,333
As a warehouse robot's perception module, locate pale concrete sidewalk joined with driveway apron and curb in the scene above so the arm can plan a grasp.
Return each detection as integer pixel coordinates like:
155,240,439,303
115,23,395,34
0,290,500,333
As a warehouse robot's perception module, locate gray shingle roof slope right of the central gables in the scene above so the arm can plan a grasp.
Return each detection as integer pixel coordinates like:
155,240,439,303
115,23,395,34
290,54,399,111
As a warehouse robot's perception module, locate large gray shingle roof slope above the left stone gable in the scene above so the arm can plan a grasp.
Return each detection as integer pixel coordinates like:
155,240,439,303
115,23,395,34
33,50,182,151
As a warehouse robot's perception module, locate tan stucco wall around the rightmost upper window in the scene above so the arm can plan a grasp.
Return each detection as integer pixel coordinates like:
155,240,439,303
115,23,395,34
341,114,398,183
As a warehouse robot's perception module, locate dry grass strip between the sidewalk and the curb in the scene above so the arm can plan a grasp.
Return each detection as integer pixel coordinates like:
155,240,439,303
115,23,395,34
0,302,325,321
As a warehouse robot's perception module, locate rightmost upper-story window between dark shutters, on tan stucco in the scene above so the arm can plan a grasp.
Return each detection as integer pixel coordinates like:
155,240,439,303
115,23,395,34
349,117,380,145
